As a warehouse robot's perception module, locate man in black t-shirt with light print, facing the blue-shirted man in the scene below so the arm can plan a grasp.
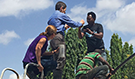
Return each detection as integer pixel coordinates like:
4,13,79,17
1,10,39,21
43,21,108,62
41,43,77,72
78,12,107,60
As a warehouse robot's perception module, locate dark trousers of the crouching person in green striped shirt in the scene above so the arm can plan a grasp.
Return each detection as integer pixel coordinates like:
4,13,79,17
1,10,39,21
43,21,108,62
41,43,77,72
76,65,109,79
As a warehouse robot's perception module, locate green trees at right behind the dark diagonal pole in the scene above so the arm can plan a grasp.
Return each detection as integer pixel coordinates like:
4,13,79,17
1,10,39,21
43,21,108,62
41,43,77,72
108,34,135,79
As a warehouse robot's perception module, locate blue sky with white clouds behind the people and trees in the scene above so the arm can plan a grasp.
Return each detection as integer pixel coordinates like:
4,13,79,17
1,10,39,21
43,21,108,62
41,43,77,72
0,0,135,79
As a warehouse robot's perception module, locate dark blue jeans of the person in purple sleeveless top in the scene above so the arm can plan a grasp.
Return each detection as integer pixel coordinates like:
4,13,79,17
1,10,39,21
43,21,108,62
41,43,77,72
23,59,57,79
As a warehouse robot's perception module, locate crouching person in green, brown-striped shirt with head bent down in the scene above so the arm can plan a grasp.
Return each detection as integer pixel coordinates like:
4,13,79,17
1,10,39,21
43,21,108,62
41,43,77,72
76,49,114,79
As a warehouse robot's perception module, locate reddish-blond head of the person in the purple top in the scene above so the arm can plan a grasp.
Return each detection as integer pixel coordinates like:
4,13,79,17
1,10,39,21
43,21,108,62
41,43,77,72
40,25,57,40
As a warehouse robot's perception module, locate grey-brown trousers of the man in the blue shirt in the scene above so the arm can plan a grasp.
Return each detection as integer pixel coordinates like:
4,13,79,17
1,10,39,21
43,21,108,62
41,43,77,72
50,33,66,79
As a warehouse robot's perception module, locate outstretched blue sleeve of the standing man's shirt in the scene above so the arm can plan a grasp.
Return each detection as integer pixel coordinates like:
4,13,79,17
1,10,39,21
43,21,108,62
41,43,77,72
60,14,82,27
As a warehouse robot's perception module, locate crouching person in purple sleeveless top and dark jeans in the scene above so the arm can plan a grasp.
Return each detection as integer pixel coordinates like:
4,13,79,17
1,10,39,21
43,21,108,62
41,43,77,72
23,25,59,79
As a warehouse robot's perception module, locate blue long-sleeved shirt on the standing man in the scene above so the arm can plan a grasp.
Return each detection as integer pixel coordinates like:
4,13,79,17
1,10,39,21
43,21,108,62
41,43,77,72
48,10,82,35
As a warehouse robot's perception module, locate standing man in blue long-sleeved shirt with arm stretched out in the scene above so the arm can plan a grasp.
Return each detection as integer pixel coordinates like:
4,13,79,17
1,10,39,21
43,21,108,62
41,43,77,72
48,1,84,79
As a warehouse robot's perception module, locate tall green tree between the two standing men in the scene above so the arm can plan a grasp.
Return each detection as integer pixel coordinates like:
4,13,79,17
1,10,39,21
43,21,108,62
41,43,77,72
62,28,87,79
